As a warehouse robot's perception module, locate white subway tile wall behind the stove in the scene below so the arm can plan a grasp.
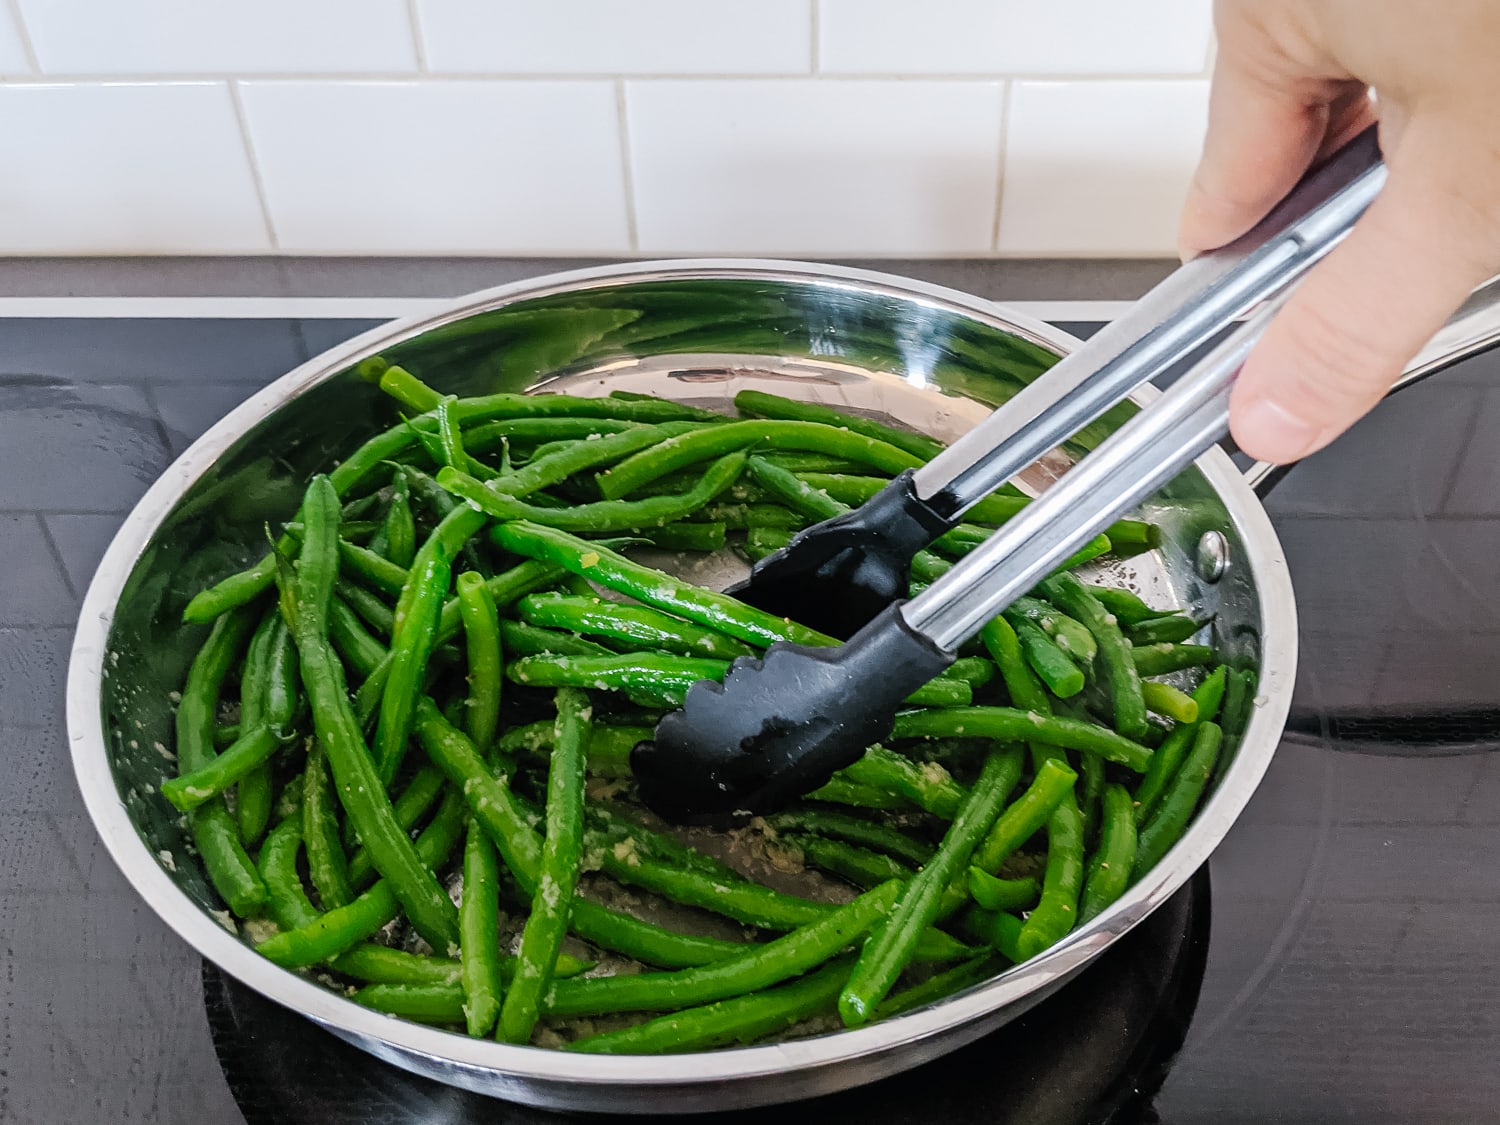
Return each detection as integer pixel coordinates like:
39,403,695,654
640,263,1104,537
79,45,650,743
0,0,1211,257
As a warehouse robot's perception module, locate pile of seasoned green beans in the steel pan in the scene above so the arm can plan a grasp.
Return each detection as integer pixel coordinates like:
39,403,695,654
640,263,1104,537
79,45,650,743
159,375,1256,1053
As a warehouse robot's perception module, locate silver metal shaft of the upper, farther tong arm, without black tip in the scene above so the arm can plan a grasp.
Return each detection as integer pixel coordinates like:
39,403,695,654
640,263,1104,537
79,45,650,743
914,126,1386,522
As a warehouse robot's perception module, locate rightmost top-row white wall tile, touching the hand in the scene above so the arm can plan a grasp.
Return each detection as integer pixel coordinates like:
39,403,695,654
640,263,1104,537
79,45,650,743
818,0,1211,75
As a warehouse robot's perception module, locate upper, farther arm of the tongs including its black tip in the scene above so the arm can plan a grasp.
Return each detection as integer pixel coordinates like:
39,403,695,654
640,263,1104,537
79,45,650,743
728,128,1385,638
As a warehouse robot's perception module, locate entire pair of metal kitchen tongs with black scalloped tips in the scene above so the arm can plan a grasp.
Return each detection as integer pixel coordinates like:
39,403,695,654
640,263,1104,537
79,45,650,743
632,129,1386,822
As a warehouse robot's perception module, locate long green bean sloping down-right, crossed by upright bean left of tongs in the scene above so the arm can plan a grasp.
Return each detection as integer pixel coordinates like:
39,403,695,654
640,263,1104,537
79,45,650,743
417,698,743,968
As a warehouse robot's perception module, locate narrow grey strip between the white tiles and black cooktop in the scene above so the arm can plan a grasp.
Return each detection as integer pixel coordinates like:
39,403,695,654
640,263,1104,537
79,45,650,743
0,255,1176,302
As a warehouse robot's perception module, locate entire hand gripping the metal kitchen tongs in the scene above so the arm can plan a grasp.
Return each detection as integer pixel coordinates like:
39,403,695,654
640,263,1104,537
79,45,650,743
1179,0,1500,464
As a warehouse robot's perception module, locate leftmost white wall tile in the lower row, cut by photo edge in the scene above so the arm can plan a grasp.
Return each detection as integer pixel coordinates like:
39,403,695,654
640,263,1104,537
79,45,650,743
0,83,272,254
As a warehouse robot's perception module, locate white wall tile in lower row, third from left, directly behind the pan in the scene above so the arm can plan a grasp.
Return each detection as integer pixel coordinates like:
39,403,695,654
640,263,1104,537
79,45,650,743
626,80,1002,255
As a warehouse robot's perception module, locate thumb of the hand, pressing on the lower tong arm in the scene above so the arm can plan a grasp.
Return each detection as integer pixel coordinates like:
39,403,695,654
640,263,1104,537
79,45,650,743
1230,122,1500,464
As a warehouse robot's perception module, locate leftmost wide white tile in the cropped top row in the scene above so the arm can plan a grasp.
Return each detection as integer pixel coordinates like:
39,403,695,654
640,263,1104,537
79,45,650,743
20,0,417,75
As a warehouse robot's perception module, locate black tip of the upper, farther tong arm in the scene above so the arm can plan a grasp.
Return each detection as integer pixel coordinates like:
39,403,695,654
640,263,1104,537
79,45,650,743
726,471,951,638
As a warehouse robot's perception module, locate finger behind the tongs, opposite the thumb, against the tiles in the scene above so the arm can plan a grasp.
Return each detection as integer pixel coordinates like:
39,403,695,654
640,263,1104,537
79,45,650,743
1178,48,1347,257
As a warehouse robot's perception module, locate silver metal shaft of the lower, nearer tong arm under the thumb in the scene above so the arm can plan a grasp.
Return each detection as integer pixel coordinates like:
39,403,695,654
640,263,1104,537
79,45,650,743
900,300,1290,653
